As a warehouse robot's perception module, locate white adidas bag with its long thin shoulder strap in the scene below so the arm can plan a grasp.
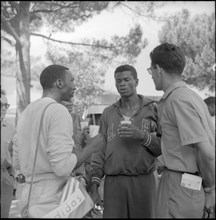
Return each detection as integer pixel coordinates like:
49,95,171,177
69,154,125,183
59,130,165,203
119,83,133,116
25,102,94,218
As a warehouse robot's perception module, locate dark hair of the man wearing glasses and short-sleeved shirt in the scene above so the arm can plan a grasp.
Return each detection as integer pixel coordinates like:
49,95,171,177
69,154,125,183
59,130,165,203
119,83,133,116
150,43,186,75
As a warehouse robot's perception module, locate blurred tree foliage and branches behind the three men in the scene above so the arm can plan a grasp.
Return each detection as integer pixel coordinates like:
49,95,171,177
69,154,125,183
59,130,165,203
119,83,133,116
1,1,215,120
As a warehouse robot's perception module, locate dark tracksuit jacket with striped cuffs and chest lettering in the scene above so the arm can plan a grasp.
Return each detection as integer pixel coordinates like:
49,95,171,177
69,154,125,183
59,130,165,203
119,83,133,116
91,95,161,184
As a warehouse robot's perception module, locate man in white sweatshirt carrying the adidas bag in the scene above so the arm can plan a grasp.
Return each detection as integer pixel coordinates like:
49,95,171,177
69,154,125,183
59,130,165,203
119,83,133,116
13,65,103,218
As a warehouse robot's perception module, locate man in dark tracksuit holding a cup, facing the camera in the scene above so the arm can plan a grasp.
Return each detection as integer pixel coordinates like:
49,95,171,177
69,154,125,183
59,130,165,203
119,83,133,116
90,65,161,218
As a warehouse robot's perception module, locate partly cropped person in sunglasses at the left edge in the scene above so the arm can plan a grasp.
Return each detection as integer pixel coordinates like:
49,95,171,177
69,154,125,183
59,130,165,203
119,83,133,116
1,89,15,218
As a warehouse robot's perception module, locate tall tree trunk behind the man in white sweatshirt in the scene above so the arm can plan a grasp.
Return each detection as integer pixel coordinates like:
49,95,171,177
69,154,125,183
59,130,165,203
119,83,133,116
16,1,31,121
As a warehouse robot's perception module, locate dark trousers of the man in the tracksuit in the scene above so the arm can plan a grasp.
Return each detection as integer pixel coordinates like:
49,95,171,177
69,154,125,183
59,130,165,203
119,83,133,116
103,173,156,218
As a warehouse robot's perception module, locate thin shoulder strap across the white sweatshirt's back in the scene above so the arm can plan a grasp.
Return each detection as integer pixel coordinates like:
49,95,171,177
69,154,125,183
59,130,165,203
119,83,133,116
27,102,55,212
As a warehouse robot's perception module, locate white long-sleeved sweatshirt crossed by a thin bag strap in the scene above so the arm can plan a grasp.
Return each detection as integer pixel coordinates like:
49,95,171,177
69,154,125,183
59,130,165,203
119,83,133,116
13,97,77,182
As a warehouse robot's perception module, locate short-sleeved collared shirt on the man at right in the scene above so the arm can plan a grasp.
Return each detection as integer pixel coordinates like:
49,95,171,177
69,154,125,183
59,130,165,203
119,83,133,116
158,82,215,173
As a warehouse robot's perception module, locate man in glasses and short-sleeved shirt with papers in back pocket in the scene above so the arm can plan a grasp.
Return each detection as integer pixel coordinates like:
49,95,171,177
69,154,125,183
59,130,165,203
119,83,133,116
148,43,215,218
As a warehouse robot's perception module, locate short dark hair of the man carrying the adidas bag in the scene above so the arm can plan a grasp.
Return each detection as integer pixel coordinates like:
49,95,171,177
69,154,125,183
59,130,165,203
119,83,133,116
40,65,69,89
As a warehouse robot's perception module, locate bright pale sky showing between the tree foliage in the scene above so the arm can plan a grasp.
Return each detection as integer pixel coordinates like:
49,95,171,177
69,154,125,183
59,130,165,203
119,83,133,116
38,1,215,97
